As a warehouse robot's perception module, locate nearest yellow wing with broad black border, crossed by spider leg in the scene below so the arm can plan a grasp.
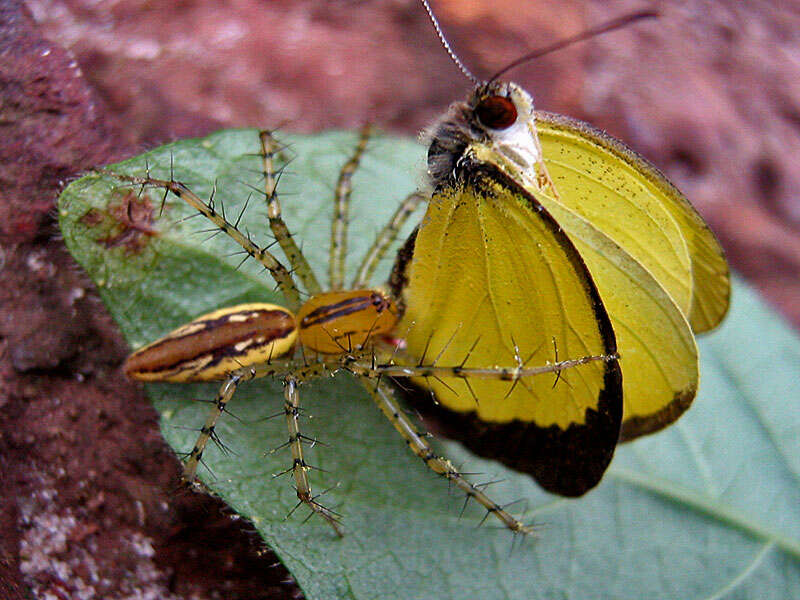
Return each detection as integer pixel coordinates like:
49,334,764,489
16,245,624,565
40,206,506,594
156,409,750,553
397,163,622,495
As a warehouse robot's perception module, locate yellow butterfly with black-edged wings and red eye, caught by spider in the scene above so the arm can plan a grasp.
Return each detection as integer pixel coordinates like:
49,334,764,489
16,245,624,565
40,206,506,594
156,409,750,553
392,7,730,496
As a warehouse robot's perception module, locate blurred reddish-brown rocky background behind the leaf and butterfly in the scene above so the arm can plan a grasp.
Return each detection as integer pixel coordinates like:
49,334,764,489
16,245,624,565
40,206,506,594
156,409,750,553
0,0,800,600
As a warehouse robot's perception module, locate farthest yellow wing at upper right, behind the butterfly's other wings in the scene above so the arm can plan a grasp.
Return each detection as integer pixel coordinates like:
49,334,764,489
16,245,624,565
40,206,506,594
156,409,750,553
536,112,730,333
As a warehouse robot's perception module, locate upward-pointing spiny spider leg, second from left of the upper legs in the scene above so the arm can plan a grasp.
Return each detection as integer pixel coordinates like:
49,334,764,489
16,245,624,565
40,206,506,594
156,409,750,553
258,130,322,295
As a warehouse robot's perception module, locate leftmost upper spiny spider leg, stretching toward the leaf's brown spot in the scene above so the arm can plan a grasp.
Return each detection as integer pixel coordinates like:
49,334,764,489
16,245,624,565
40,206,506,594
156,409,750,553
103,171,301,310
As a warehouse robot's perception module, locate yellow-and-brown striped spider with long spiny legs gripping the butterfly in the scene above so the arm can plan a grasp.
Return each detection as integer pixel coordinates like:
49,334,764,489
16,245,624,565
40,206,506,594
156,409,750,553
111,128,616,536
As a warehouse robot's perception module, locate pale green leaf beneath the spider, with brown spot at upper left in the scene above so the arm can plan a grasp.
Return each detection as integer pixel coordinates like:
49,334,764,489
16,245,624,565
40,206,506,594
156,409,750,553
59,130,800,600
